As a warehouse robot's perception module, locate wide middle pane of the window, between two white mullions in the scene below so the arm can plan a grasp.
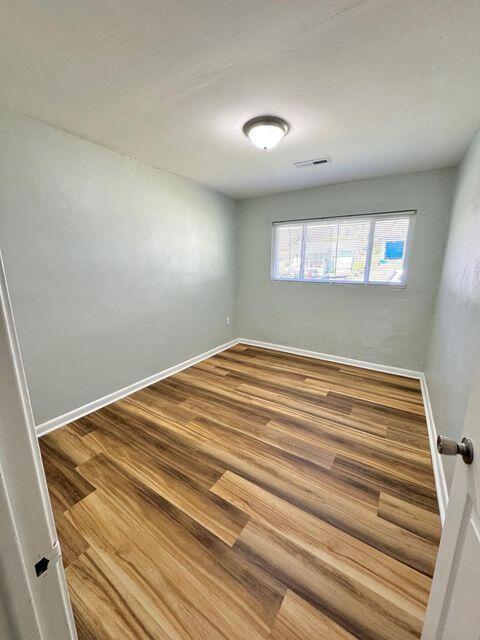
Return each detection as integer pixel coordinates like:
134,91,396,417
304,220,371,282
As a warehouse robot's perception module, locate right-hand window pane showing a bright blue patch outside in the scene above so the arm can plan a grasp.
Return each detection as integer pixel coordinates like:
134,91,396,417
369,218,410,284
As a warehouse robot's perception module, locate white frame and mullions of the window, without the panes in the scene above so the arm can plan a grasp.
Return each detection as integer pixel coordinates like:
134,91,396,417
270,209,417,289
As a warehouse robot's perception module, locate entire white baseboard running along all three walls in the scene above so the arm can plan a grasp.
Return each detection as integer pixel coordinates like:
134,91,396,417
36,338,448,524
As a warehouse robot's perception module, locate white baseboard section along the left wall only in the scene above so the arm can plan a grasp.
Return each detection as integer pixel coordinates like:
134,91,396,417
36,340,238,437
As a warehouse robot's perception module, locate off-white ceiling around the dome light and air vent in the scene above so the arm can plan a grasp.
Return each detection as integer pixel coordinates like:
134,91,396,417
0,0,480,198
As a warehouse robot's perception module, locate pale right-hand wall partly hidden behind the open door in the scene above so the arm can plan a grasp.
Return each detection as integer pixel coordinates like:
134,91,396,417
426,132,480,486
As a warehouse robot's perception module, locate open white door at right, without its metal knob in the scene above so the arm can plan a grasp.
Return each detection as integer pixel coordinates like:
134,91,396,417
422,358,480,640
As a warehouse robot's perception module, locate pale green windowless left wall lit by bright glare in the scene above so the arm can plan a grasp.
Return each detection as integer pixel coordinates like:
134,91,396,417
0,111,237,424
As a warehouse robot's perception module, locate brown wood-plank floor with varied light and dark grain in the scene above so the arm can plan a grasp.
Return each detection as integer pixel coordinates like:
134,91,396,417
40,345,440,640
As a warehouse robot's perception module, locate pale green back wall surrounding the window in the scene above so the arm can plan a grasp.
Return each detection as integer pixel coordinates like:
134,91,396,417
238,169,455,370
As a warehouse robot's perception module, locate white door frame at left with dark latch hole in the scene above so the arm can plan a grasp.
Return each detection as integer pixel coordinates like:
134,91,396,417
0,254,76,640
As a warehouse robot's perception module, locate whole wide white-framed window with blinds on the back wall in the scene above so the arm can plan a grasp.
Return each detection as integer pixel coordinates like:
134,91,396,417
272,211,415,286
